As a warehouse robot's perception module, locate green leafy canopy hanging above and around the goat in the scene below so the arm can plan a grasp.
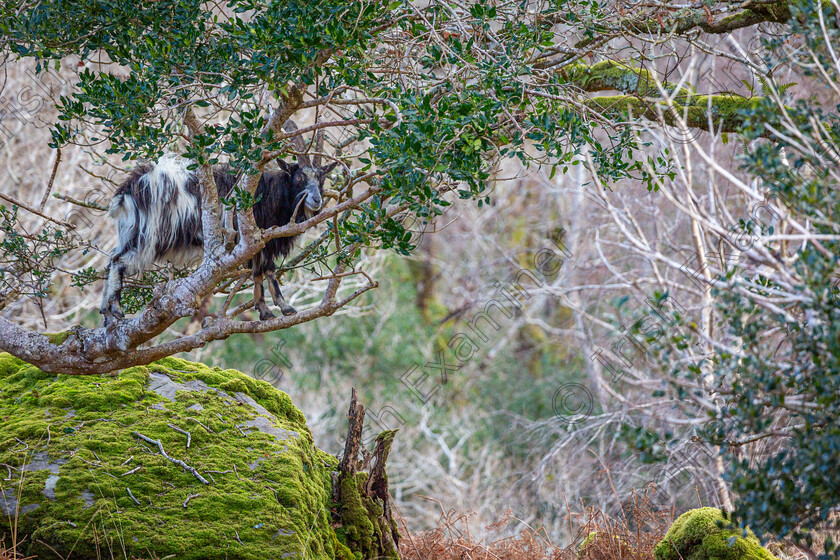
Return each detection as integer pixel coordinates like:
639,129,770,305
0,0,671,278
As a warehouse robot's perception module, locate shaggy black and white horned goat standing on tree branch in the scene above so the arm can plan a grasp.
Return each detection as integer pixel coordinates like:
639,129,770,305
100,125,337,326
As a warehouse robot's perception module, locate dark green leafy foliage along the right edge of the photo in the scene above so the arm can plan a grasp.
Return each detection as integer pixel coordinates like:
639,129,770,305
715,3,840,557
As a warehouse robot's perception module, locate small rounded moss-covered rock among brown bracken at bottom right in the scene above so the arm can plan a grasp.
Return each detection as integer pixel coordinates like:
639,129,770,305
653,508,776,560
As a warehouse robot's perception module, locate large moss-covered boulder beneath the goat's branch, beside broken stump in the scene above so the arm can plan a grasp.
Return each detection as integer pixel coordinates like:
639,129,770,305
0,354,382,560
